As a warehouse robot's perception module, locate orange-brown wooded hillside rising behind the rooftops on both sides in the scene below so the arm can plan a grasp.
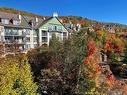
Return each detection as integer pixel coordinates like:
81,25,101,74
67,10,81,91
0,8,127,32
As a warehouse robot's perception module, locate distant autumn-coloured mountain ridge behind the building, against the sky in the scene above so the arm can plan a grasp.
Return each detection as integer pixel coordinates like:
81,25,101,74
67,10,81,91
0,7,127,30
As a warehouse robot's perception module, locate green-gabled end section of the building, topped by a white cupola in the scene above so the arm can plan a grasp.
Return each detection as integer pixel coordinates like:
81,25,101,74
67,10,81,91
38,13,68,46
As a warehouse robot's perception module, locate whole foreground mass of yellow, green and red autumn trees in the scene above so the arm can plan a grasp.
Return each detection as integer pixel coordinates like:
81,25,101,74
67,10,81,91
0,29,127,95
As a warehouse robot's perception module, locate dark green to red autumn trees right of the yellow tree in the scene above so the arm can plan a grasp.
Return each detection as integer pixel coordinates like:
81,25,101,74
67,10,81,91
28,30,124,95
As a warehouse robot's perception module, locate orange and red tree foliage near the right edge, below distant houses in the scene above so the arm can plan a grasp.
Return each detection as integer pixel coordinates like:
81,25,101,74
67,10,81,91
97,30,124,54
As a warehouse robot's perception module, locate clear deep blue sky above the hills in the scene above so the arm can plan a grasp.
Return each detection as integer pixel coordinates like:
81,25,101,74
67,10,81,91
0,0,127,24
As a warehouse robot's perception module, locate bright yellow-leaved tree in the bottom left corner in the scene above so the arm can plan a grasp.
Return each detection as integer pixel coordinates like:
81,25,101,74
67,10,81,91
0,56,37,95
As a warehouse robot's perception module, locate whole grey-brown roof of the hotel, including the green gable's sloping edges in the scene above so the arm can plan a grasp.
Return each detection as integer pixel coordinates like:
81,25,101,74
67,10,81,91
0,12,68,31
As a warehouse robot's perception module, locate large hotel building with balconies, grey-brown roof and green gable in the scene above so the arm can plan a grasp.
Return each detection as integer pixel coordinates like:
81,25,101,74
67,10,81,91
0,12,68,53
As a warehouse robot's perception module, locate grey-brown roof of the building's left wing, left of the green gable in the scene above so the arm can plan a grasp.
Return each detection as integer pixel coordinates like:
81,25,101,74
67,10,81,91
0,12,44,29
